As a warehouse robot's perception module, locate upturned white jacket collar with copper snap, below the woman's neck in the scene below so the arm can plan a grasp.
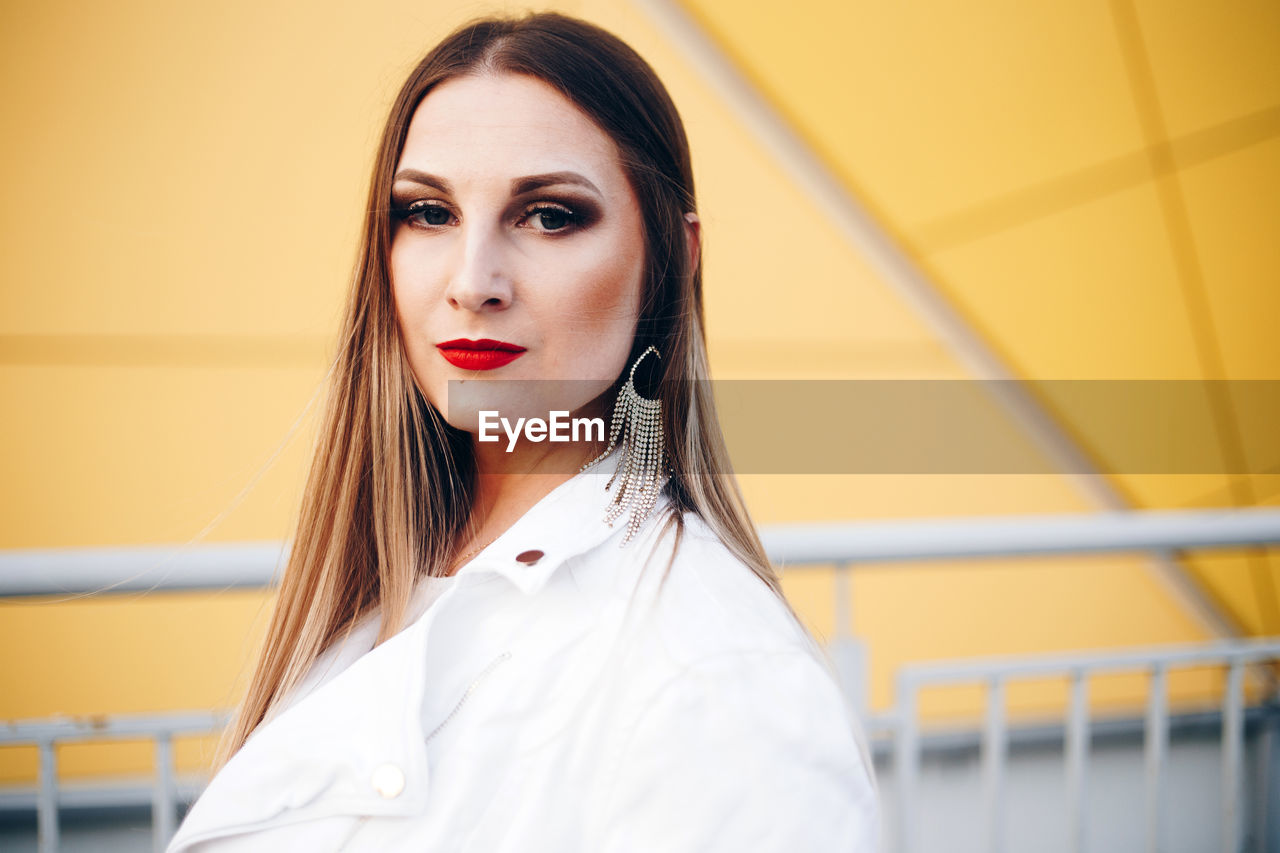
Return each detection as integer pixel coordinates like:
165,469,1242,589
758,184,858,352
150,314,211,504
457,447,669,594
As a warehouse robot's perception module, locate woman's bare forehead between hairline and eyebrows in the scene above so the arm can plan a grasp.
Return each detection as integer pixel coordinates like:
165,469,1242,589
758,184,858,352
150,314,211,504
397,74,623,188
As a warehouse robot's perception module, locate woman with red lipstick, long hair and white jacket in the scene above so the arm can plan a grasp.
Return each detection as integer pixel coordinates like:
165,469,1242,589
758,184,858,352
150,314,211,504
169,13,877,853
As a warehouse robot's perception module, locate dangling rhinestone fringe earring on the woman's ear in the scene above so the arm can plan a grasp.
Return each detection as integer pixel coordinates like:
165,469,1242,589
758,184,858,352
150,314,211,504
579,347,666,544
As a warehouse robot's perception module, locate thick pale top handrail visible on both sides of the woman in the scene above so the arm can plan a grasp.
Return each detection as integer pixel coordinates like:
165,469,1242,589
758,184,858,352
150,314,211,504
0,507,1280,597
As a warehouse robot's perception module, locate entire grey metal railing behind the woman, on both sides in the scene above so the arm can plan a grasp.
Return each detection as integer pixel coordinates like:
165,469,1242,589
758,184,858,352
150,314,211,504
0,508,1280,853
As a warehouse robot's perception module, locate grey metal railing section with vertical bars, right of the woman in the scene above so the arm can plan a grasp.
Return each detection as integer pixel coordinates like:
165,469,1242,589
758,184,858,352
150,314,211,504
762,508,1280,853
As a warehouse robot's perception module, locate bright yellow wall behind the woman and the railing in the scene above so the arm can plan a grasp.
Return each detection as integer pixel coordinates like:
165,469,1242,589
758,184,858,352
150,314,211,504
0,0,1280,779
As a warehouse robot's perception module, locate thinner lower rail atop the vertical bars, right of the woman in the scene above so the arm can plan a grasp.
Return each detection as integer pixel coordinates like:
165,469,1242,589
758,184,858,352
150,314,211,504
900,637,1280,686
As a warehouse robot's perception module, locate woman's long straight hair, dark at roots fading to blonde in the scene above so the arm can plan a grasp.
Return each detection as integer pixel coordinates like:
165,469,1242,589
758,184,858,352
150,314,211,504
215,13,800,766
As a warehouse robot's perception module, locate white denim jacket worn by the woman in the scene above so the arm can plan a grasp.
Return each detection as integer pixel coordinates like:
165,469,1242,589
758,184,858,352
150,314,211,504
168,452,879,853
